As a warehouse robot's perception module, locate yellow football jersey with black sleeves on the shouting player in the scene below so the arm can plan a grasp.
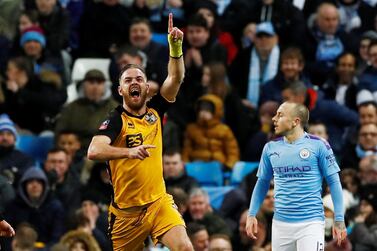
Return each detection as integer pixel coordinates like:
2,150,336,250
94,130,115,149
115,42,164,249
97,94,170,208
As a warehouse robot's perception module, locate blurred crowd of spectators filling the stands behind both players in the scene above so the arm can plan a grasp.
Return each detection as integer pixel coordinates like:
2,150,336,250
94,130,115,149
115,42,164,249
0,0,377,251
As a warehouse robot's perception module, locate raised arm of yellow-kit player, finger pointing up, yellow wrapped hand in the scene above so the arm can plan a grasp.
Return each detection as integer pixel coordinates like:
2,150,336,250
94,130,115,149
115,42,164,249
160,13,185,101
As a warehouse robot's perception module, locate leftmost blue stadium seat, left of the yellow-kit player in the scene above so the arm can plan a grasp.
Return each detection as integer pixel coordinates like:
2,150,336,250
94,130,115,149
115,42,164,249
16,135,54,164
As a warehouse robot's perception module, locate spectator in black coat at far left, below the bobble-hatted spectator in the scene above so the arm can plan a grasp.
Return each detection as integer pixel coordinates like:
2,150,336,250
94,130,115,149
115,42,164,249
0,55,67,133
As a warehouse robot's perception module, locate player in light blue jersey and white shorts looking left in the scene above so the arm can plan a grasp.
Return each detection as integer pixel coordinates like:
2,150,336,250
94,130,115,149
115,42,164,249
246,102,347,251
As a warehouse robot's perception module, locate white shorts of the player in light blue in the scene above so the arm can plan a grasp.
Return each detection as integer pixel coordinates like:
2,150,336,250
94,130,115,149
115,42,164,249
271,220,325,251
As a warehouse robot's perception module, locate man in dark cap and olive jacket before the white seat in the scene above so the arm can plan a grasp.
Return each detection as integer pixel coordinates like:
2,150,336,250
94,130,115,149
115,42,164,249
55,69,118,149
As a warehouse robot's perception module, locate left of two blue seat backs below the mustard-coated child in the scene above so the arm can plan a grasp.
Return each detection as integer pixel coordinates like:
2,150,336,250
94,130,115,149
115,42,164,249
185,161,223,186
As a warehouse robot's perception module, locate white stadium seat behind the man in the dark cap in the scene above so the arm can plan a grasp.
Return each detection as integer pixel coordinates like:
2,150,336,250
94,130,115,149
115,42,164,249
66,58,111,104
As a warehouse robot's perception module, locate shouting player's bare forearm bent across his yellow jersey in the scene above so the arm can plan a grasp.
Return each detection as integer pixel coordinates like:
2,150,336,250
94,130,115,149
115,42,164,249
88,135,155,161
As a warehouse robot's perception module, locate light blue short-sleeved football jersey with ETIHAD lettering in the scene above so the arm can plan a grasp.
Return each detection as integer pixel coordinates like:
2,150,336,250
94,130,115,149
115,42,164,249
257,133,340,223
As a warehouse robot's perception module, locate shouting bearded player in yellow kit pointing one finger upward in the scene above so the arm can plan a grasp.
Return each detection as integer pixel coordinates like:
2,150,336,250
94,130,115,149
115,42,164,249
88,14,193,251
